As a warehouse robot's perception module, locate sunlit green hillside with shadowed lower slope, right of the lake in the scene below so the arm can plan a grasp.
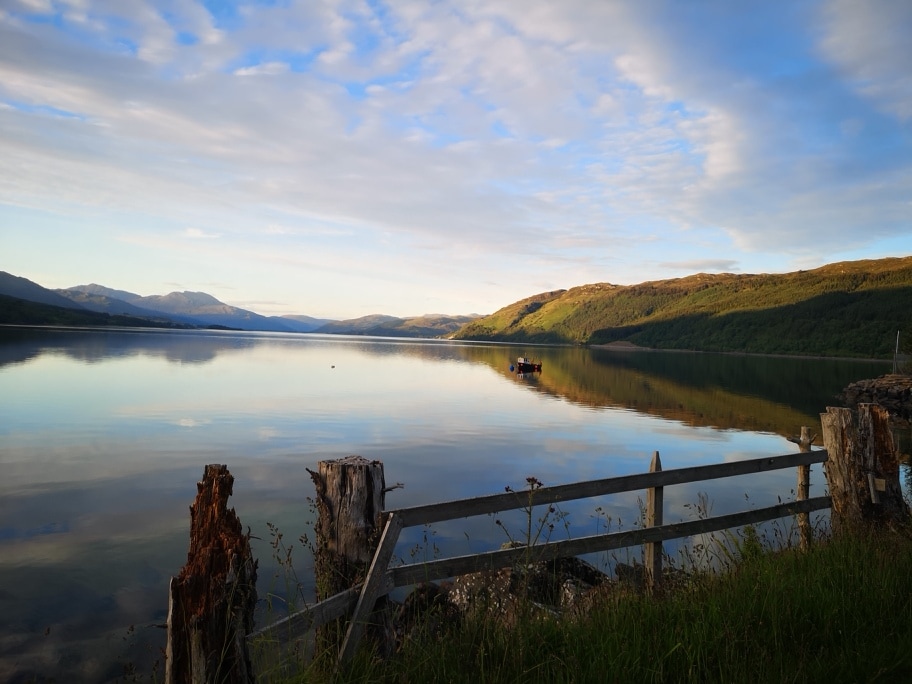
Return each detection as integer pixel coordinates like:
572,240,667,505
454,257,912,358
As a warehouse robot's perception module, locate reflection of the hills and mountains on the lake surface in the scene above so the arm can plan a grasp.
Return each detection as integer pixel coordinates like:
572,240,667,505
0,328,889,435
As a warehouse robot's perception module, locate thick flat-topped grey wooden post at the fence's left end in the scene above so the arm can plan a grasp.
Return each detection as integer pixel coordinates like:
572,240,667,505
308,456,392,659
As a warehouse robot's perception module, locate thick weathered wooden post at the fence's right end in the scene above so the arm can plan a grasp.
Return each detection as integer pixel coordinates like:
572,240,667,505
820,404,909,532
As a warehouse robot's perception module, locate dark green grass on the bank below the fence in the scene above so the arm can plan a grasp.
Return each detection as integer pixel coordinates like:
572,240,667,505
273,529,912,684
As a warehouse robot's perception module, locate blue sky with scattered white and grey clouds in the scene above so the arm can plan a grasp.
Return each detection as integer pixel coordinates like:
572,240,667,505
0,0,912,318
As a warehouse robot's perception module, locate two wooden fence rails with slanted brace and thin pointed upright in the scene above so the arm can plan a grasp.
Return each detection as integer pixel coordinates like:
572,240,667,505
248,450,831,663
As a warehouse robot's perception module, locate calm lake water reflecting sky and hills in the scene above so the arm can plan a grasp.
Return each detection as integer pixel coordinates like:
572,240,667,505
0,328,890,682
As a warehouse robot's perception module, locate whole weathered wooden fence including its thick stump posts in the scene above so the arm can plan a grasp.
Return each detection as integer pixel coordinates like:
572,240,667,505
165,404,912,684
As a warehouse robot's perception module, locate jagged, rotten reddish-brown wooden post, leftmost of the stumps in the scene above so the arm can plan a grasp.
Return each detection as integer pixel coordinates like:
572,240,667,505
165,465,257,684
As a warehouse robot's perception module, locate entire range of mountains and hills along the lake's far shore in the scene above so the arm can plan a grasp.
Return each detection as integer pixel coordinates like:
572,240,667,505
0,256,912,358
